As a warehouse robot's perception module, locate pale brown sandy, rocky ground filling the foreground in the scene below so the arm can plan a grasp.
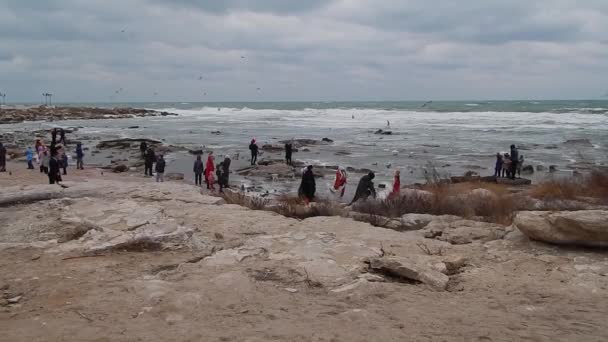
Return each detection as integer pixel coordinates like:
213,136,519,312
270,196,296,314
0,164,608,341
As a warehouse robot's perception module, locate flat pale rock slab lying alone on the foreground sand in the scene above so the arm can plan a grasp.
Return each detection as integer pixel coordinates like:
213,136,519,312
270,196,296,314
370,257,450,291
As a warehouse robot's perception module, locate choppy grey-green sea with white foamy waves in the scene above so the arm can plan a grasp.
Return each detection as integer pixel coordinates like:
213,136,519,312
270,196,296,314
0,100,608,195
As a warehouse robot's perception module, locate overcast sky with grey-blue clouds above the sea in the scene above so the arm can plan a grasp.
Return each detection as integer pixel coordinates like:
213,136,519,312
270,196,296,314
0,0,608,102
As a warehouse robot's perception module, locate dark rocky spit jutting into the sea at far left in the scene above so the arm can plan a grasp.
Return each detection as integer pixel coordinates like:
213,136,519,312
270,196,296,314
0,106,177,124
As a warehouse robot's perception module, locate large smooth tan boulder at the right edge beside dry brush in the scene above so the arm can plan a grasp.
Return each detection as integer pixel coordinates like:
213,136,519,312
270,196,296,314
513,210,608,247
